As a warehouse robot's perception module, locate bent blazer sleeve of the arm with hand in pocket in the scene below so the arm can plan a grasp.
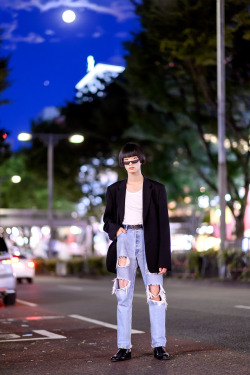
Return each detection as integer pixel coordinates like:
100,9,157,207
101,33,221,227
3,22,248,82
103,188,121,241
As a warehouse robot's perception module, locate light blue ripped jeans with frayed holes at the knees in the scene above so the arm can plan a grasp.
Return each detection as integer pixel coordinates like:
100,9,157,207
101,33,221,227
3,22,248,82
112,229,167,349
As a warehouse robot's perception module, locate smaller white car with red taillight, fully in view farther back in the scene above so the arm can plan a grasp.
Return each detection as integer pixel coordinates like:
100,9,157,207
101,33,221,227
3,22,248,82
12,251,35,284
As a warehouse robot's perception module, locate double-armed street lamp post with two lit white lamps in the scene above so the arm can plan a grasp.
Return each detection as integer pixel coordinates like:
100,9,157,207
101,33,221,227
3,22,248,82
17,133,84,257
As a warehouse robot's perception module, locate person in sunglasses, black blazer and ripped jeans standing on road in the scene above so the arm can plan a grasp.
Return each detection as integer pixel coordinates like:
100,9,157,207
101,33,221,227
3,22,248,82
103,143,171,362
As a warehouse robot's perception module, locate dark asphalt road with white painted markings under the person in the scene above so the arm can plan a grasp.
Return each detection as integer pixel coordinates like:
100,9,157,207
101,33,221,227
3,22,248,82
0,277,250,375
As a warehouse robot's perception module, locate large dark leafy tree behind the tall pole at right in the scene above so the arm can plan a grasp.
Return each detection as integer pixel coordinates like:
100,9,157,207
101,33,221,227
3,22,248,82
124,0,250,237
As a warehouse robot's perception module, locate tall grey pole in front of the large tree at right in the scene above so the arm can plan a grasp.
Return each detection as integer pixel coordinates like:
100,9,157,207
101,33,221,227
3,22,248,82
217,0,227,252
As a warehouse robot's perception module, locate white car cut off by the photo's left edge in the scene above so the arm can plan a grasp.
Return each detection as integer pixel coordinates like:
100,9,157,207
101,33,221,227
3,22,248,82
0,236,16,306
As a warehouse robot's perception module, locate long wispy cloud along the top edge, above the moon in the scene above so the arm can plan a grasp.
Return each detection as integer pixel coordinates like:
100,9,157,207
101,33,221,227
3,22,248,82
0,0,134,21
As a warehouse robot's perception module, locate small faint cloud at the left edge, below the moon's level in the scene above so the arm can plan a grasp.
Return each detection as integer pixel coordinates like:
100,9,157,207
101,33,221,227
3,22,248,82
0,19,45,50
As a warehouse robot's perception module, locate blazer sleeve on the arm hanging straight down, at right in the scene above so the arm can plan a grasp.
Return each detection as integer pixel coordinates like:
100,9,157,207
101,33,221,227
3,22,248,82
158,185,171,271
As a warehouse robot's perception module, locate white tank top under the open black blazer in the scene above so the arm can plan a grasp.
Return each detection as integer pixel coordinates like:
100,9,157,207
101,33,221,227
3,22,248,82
122,188,143,225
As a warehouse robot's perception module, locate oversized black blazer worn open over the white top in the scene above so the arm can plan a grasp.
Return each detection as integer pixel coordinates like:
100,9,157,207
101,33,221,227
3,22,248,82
103,177,171,273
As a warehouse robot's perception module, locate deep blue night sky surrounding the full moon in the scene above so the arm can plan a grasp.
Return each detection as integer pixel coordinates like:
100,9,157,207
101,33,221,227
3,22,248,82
0,0,139,149
